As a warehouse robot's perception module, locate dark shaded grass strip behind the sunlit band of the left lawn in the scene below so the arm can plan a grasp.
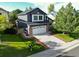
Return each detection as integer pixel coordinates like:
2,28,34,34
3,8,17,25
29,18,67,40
0,34,33,42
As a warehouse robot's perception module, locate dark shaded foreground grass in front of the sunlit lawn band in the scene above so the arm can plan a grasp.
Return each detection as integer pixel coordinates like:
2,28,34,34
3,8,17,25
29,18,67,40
0,45,44,57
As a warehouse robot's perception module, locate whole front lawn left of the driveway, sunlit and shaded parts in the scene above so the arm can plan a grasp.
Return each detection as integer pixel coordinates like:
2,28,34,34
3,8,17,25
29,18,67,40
0,34,45,57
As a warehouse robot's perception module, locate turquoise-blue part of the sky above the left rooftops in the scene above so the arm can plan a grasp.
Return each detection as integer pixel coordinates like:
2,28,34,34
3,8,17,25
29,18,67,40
0,2,34,11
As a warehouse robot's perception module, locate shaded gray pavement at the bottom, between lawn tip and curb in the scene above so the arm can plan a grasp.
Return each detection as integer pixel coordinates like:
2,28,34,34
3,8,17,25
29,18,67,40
29,49,63,57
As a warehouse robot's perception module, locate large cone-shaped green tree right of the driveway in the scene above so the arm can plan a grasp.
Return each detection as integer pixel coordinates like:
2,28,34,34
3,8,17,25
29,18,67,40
54,3,77,33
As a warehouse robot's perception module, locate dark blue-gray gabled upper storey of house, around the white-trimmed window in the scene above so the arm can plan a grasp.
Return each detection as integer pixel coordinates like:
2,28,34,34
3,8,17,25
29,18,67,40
19,8,49,23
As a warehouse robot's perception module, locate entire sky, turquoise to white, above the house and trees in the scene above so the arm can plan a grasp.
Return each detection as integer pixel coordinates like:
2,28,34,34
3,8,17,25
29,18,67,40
0,0,79,12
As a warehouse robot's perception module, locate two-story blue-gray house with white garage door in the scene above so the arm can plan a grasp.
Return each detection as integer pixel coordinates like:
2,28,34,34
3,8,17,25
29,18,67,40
16,8,51,36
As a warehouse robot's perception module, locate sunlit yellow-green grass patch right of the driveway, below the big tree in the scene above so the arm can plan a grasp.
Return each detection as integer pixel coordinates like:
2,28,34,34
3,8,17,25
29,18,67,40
54,34,75,42
